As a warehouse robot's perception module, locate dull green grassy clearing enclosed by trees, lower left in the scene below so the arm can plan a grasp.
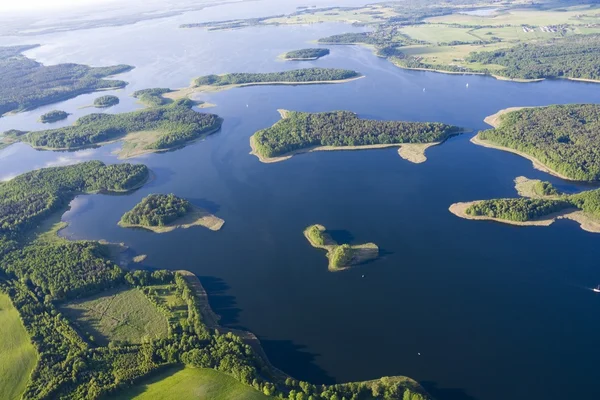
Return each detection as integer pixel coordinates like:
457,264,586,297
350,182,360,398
61,289,168,345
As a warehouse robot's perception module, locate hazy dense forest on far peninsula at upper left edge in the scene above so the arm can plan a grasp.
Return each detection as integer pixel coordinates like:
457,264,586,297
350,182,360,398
0,46,133,116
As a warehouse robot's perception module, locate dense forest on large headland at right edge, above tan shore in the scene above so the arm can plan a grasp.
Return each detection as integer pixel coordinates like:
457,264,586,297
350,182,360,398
478,104,600,181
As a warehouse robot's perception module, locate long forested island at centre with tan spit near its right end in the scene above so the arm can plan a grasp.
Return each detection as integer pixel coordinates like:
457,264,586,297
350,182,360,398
250,110,463,162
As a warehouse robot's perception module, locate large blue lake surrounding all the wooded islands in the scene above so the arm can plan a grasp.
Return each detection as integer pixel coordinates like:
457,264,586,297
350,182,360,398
0,2,600,400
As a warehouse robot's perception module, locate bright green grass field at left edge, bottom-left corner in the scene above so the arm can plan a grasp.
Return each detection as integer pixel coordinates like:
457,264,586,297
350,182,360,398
0,293,37,400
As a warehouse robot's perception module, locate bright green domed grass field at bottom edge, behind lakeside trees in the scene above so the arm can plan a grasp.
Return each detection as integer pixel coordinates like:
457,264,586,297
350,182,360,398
110,368,271,400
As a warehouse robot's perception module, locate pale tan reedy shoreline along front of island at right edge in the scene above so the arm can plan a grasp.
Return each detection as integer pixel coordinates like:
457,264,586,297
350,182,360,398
448,200,600,233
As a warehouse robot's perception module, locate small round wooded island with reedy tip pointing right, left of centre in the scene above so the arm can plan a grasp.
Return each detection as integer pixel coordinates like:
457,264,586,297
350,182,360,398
119,194,225,233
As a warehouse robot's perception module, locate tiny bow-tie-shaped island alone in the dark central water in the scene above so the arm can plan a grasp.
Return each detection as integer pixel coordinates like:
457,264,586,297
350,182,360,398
304,225,379,272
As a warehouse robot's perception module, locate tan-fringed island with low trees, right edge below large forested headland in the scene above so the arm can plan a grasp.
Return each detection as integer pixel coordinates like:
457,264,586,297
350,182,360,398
449,177,600,233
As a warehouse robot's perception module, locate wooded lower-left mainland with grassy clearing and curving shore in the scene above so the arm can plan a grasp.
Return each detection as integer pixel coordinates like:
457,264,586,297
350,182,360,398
0,161,430,400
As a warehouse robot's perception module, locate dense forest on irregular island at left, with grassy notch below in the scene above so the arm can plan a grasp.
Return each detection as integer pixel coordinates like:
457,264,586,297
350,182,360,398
6,100,223,150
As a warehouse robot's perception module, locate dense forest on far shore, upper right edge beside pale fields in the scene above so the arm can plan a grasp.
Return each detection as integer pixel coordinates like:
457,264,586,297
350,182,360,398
466,34,600,80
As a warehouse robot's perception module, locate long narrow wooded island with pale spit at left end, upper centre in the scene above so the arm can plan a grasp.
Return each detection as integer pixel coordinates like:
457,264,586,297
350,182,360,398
164,68,364,100
